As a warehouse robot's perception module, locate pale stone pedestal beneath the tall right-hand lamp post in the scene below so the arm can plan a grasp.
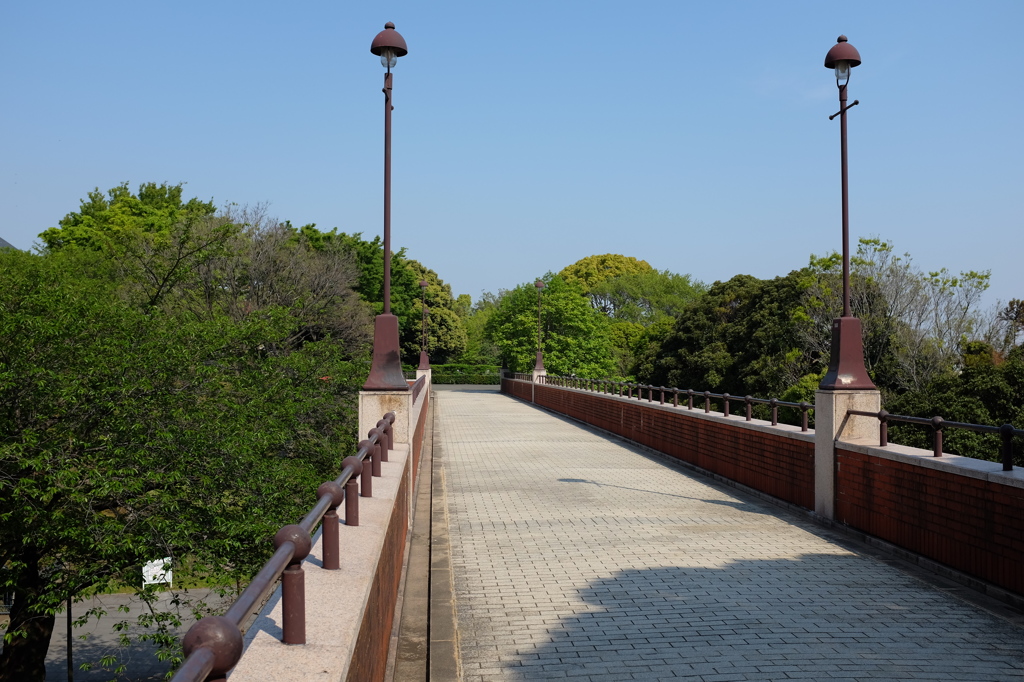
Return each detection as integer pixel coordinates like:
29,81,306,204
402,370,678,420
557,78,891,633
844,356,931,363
814,390,882,519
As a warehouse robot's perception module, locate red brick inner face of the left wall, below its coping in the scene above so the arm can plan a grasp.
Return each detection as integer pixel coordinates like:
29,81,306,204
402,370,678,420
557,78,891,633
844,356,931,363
342,450,412,682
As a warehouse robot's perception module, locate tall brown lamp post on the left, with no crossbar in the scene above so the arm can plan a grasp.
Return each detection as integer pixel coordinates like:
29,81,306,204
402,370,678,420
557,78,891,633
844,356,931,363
362,22,409,391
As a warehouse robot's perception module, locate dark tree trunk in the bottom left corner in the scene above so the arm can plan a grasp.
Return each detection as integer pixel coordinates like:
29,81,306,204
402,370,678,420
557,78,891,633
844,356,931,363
0,557,56,682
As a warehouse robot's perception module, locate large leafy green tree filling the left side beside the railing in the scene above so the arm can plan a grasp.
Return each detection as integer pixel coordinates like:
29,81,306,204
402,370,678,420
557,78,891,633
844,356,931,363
0,185,366,682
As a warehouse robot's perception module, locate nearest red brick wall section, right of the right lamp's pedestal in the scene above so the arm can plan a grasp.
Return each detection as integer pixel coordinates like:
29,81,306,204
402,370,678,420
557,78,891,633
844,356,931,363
836,447,1024,594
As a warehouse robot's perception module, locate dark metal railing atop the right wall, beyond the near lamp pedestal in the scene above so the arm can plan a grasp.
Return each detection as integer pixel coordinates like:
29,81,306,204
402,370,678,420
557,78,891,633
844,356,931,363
541,375,814,431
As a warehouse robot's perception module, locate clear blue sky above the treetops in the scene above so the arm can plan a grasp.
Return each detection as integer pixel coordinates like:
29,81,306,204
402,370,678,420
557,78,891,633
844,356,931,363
0,0,1024,304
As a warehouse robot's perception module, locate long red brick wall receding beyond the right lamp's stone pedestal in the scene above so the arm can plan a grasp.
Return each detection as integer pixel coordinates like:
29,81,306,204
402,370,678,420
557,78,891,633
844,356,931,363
502,381,814,509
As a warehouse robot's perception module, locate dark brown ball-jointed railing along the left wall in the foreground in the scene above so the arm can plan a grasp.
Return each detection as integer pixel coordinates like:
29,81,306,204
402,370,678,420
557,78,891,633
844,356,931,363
172,409,397,682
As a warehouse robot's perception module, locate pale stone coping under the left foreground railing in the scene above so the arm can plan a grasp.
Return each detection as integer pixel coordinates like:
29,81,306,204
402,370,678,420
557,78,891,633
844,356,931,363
228,442,410,682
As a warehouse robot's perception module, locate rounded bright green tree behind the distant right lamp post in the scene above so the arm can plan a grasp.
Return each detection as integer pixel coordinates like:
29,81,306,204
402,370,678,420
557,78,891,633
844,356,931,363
486,273,614,377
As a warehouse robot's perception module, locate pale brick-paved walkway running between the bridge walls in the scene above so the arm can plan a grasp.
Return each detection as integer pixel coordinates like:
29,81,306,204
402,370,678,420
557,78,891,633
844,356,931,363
434,387,1024,682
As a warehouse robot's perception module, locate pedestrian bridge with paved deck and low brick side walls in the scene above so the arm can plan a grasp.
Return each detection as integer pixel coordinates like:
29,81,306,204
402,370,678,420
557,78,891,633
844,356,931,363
178,379,1024,682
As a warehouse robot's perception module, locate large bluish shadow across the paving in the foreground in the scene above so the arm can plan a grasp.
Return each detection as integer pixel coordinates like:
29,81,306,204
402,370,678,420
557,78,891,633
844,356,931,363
505,554,1024,682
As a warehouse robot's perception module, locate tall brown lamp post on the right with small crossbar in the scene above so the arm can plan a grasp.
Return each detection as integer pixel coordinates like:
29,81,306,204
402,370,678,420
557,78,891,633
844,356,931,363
818,36,874,390
